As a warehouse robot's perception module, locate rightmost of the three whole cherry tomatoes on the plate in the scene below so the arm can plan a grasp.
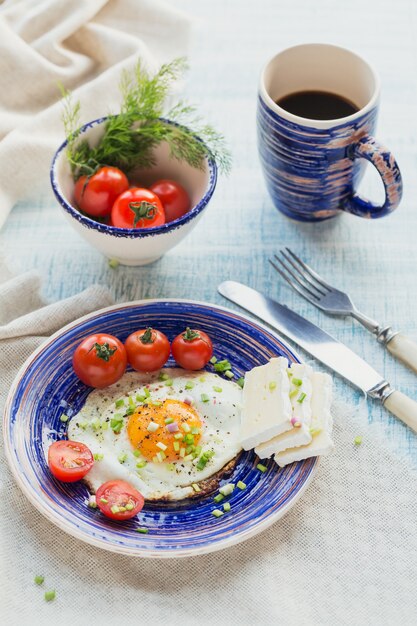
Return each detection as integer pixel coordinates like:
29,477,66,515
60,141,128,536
171,328,213,370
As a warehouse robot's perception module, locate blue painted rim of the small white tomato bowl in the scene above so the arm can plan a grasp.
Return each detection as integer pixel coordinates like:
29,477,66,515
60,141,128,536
50,116,217,239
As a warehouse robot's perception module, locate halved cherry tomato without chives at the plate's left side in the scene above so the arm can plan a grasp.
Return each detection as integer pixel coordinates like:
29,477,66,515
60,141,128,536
48,439,94,483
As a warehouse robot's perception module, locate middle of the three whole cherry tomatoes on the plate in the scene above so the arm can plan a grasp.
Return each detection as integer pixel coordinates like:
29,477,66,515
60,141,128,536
125,327,171,372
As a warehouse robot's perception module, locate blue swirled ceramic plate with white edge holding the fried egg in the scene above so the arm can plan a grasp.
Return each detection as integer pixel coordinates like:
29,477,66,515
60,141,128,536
3,300,317,558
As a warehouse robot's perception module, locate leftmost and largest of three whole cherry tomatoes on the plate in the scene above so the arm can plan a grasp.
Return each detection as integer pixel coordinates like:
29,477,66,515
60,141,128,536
72,333,127,388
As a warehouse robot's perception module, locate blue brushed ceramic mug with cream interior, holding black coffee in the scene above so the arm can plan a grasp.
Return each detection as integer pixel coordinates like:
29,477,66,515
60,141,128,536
257,44,402,222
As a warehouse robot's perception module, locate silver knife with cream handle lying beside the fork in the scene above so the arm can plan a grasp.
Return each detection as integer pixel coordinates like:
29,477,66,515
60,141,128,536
218,280,417,432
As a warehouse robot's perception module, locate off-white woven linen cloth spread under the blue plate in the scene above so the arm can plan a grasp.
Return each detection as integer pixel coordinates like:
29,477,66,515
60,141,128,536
0,268,417,626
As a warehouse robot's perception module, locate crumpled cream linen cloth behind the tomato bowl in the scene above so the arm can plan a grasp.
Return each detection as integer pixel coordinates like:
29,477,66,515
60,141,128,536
0,0,191,228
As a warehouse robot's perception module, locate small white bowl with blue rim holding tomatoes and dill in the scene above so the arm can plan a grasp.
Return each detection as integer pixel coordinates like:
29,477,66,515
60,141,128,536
50,117,217,265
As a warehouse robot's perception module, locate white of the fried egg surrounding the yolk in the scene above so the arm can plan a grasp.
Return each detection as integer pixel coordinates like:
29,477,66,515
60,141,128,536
68,368,242,500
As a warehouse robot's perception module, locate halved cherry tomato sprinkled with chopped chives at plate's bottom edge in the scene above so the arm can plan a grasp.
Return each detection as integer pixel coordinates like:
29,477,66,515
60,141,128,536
96,480,145,520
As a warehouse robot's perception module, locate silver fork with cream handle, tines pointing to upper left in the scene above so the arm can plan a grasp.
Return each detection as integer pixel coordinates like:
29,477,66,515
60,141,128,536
269,248,417,373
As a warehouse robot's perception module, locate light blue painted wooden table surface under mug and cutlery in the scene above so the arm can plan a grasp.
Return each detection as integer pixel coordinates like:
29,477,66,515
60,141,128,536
0,0,417,466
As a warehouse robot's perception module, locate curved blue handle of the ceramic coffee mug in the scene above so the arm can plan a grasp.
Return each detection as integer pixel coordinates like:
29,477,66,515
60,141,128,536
342,135,403,219
